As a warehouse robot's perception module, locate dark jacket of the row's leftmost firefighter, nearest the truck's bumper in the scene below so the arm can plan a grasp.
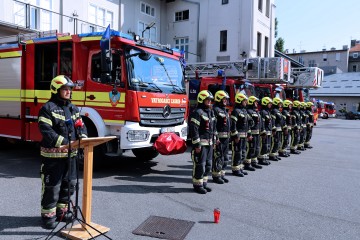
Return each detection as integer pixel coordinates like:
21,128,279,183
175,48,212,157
189,104,216,148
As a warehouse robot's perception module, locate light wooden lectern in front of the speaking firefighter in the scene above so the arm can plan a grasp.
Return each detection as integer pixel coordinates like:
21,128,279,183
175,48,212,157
61,136,116,240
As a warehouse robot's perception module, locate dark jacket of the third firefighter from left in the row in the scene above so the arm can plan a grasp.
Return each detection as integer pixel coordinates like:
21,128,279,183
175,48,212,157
230,106,254,139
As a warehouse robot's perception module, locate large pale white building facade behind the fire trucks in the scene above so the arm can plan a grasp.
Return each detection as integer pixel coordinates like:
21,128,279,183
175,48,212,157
0,0,276,62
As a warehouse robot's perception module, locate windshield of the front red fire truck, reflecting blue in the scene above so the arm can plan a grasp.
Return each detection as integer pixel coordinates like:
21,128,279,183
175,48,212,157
127,49,185,94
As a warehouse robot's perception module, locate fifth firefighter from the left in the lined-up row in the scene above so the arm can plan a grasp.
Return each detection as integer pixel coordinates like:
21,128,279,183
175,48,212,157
260,97,277,161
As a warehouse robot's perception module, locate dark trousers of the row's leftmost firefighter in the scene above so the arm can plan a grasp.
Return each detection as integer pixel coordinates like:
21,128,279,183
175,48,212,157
191,145,213,187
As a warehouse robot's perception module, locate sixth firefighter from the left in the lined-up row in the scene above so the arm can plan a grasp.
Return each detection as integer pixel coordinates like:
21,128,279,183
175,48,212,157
270,97,284,160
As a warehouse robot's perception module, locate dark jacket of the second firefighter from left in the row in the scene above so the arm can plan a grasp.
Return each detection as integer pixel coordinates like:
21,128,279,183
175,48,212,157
213,104,230,139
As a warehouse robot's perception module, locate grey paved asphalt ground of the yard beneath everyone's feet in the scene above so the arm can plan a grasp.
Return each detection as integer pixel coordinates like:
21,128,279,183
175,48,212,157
0,119,360,240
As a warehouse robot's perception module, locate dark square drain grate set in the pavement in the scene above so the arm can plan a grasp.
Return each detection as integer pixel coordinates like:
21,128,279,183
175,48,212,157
132,216,195,240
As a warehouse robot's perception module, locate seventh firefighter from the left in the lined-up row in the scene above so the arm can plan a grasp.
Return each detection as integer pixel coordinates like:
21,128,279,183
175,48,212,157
279,100,292,157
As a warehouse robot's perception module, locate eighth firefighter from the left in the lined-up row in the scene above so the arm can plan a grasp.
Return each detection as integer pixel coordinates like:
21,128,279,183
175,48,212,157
290,100,302,154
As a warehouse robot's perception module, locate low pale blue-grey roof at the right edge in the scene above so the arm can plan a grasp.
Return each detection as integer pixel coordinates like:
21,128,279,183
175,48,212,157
310,72,360,97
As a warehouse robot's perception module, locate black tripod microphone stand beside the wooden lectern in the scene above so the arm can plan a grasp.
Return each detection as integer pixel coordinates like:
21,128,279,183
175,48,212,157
45,122,112,240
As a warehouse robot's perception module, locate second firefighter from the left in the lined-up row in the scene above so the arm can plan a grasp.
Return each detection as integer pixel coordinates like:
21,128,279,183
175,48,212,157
212,90,230,184
